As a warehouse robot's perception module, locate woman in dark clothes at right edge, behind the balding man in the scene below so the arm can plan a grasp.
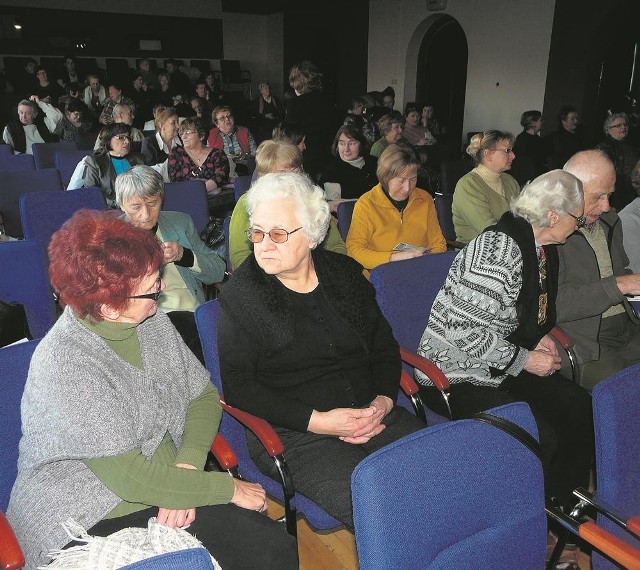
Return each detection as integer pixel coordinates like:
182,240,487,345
596,113,640,211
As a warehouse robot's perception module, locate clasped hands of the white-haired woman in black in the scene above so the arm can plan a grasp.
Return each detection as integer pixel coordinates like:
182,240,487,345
308,396,393,444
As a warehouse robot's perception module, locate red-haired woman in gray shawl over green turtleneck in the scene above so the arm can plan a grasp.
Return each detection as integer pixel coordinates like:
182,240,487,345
7,210,297,568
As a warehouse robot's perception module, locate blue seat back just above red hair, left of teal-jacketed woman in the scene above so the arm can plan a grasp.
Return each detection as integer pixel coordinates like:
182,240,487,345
20,187,107,247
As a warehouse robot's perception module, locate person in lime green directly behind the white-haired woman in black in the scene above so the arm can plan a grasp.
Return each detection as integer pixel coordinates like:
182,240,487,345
228,140,347,271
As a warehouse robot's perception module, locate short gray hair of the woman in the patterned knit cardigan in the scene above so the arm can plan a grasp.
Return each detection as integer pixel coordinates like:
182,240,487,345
511,170,584,228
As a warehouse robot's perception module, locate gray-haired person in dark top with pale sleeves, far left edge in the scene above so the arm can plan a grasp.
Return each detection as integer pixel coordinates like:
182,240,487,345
2,95,62,154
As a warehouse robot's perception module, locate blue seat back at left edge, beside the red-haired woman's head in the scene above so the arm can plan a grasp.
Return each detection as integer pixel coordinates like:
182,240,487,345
0,240,56,338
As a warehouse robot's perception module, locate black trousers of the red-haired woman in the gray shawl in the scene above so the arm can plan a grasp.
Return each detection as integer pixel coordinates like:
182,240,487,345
88,504,298,570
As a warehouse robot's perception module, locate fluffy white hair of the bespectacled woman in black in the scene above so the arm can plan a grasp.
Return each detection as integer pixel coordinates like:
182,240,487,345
247,172,331,245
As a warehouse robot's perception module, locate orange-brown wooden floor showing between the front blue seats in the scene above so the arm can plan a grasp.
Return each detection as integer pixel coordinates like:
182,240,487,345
267,499,591,570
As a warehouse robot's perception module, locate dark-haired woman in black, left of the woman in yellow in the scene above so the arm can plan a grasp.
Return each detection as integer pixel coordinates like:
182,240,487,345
320,125,378,212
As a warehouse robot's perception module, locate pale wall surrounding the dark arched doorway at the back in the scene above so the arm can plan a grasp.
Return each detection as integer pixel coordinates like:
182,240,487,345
367,0,555,133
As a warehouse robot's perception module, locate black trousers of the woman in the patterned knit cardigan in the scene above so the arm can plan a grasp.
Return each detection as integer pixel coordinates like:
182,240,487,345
420,371,594,508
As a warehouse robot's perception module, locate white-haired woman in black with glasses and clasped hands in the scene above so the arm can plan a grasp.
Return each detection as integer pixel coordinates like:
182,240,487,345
218,173,424,528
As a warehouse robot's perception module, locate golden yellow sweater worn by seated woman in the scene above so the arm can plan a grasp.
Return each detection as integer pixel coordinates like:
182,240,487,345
347,184,447,270
